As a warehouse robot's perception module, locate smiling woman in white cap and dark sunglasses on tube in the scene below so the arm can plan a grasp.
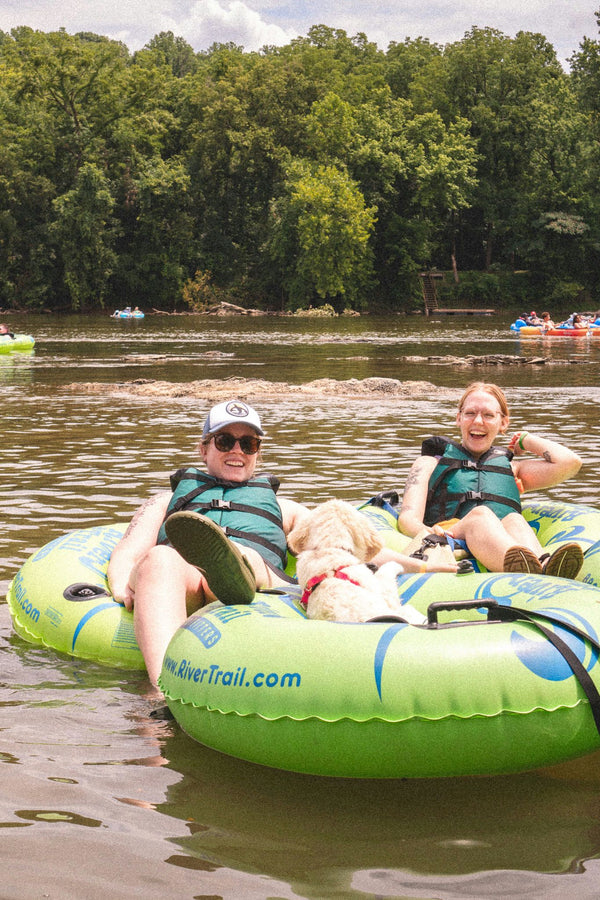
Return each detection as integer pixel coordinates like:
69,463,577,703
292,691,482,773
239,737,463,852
108,400,306,684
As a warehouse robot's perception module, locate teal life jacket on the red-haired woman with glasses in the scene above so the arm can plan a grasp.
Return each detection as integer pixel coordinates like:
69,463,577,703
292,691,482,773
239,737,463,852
421,437,521,526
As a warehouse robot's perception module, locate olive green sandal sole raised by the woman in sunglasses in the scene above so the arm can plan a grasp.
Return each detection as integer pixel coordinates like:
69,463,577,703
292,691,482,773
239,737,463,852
165,512,256,606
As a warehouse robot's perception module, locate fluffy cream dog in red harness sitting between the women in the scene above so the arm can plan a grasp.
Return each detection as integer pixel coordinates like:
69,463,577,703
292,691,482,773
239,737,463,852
288,500,425,625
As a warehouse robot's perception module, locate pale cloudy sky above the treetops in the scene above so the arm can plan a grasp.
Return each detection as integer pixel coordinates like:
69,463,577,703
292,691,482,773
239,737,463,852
0,0,600,65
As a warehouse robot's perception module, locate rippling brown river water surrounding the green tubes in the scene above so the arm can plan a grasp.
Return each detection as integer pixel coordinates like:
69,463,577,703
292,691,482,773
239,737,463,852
0,316,600,900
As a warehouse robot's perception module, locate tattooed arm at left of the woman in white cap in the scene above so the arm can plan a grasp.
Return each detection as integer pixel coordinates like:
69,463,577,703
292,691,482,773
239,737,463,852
107,491,171,609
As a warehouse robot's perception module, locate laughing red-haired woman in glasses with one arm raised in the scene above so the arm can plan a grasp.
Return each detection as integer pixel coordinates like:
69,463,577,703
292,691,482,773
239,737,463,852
398,381,583,578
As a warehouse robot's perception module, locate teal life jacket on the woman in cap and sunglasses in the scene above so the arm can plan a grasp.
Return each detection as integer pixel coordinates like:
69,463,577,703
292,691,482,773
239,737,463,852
157,466,287,571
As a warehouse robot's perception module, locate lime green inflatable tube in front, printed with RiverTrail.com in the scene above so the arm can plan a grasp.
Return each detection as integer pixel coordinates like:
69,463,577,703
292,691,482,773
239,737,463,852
160,574,600,778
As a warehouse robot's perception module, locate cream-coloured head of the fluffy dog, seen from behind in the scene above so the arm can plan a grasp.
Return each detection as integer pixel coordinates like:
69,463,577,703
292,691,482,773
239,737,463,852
287,500,383,562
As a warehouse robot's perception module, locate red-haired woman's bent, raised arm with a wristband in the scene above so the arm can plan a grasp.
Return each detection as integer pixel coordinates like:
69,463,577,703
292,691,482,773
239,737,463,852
509,431,581,491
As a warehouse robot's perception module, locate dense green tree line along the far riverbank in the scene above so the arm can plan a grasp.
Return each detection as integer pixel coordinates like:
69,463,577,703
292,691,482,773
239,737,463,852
0,18,600,311
